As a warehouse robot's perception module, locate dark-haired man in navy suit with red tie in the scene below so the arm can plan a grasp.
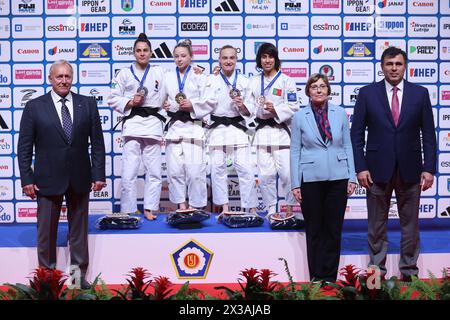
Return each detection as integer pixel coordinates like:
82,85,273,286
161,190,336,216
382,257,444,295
351,47,436,281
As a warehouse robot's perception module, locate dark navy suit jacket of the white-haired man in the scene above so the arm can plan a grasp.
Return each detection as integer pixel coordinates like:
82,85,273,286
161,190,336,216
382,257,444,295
17,92,105,196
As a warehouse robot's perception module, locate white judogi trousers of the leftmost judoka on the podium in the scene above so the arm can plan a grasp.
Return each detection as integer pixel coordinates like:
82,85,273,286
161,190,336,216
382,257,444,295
120,137,162,213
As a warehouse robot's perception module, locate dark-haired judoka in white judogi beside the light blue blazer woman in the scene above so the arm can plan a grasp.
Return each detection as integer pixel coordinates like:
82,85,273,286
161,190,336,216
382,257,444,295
251,43,299,216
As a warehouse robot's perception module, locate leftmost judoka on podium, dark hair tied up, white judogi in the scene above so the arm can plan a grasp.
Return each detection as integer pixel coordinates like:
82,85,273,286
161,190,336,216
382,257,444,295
108,33,165,220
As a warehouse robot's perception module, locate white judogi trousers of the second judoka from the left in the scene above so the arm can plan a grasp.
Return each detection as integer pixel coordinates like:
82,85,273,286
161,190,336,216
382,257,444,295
166,139,208,208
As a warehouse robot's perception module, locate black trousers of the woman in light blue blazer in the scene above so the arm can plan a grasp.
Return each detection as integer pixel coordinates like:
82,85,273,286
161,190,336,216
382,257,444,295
301,179,348,282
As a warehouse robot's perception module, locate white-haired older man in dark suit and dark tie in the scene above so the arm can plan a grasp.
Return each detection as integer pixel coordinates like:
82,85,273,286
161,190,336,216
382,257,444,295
18,60,105,289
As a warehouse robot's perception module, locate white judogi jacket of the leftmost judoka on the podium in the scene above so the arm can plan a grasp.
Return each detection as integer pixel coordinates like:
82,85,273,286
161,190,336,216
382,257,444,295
108,64,165,140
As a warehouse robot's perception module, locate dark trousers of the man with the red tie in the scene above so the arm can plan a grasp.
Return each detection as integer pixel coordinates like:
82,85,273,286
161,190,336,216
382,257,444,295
367,168,420,276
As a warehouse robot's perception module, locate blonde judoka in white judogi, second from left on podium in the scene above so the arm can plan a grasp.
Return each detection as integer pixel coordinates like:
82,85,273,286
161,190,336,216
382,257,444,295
164,40,214,209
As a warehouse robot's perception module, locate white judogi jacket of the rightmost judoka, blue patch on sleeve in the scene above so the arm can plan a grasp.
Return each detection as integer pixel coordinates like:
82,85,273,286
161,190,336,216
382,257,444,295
250,74,300,146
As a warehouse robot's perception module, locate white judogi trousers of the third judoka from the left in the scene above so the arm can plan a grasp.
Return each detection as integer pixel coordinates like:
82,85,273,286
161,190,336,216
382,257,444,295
209,146,258,209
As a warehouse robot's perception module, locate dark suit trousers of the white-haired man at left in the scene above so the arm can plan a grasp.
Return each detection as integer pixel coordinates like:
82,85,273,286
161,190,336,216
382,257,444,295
37,187,89,276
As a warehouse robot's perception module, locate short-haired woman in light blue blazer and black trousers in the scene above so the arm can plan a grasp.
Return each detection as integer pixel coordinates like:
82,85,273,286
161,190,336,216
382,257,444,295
290,74,356,283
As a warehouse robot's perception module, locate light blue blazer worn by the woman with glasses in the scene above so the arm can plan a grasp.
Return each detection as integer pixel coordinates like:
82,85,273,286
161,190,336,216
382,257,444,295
291,103,356,189
